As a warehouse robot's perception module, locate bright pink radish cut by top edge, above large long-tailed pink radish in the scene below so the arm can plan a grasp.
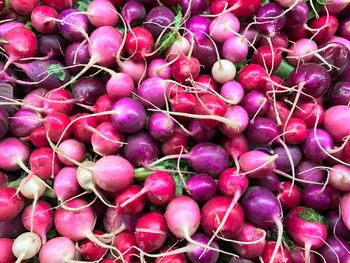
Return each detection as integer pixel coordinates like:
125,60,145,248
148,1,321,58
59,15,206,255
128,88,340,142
86,0,119,27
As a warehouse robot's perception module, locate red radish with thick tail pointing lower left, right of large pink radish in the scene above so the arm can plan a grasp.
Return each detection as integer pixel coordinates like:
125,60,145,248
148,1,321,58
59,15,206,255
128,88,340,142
120,172,175,207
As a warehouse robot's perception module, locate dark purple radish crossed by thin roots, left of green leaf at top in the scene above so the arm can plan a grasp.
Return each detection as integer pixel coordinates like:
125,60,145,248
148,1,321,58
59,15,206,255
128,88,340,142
144,6,175,38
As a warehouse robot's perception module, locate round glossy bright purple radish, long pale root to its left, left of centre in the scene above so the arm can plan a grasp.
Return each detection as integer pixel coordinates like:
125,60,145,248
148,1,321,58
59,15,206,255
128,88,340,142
111,98,146,133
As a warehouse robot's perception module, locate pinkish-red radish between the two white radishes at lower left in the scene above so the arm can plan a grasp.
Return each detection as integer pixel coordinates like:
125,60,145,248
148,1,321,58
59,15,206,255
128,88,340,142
22,201,54,244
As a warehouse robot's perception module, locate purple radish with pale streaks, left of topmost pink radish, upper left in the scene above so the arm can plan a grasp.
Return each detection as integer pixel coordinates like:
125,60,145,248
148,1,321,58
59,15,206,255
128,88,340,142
58,8,89,41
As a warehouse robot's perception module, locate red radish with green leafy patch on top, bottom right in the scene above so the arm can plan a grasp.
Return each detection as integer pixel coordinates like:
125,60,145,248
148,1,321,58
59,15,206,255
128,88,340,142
286,206,327,262
